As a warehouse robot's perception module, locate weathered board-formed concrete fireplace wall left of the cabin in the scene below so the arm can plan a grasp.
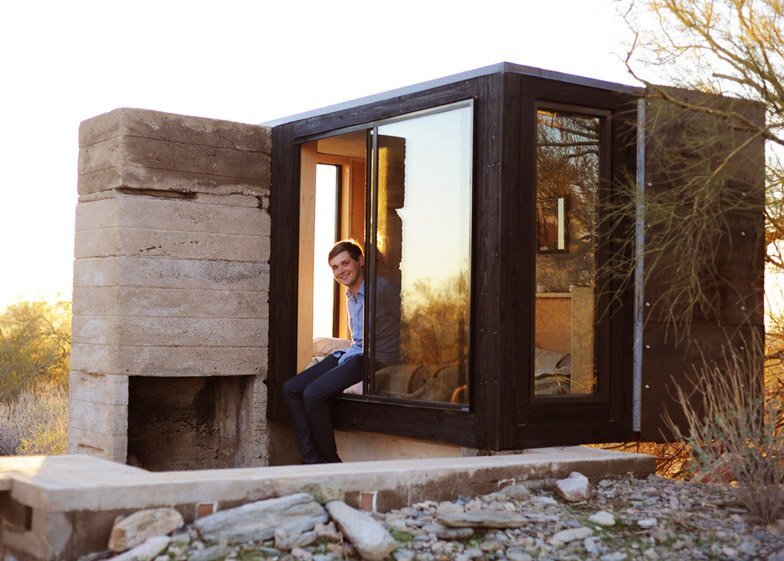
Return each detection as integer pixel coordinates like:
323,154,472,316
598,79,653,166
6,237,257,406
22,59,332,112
69,109,271,467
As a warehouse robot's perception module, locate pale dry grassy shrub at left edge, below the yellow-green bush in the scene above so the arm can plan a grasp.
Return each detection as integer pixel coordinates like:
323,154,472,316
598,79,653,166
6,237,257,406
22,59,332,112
0,383,68,455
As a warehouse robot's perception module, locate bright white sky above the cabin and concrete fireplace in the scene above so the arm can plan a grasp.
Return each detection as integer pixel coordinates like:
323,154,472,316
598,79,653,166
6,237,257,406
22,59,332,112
0,0,635,309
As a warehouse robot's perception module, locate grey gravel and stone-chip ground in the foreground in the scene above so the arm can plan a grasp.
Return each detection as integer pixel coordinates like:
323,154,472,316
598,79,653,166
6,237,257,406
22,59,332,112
87,476,784,561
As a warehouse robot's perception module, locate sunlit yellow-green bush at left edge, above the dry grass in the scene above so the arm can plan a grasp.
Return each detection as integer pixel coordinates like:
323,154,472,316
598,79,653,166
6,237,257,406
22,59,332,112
0,301,71,399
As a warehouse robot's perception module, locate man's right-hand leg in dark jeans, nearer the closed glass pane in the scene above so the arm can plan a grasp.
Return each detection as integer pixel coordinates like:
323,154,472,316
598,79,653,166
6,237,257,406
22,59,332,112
303,356,364,462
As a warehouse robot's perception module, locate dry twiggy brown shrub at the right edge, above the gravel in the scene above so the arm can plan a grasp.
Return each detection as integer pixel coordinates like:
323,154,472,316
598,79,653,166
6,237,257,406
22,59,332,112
668,353,784,523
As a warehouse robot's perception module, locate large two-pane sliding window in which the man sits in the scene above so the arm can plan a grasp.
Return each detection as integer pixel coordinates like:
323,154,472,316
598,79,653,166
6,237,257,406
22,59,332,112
297,103,473,404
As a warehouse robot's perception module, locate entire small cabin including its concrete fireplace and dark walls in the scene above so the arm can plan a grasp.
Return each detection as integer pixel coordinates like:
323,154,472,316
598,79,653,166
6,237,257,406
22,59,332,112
69,63,765,470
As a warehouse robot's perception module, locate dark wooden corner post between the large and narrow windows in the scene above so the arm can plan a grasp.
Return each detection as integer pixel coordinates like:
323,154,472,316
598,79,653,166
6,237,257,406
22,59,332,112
472,74,516,450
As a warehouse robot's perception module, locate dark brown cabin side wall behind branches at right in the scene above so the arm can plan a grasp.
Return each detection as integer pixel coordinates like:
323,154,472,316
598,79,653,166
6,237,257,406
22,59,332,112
640,89,765,441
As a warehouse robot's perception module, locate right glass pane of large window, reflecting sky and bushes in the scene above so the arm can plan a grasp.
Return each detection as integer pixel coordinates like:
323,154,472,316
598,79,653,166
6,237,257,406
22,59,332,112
372,107,472,403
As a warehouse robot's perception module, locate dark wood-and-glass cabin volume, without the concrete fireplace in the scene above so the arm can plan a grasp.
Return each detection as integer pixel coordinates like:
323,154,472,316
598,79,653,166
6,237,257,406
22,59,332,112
268,63,764,450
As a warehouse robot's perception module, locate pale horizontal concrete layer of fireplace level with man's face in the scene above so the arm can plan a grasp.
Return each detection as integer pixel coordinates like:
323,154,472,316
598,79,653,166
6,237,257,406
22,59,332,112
74,256,269,290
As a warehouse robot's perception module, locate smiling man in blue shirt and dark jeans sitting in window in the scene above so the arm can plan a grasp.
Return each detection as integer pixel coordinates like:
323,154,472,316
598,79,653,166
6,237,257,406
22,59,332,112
283,240,400,464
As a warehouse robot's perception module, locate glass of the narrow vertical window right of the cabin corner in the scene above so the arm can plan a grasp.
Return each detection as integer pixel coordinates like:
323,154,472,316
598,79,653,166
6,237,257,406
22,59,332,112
534,110,601,396
